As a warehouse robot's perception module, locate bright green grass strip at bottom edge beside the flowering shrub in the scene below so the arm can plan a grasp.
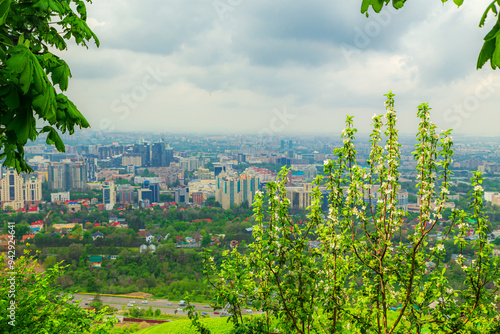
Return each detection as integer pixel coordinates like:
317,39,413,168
136,318,233,334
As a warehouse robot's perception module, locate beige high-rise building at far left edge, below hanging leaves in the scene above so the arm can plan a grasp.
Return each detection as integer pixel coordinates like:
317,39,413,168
0,169,42,210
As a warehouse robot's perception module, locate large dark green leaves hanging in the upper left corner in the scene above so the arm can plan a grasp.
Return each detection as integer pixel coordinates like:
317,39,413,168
0,0,99,172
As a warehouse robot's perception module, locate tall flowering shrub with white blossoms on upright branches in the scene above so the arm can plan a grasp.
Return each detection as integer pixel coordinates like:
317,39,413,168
194,93,500,333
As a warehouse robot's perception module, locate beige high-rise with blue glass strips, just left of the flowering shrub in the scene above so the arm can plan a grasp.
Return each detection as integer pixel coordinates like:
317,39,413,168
215,173,259,210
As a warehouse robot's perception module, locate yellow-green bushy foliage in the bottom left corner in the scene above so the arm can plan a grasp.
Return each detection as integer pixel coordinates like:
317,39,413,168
0,249,112,334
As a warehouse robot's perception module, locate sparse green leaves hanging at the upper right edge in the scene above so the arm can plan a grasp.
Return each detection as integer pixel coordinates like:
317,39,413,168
361,0,500,69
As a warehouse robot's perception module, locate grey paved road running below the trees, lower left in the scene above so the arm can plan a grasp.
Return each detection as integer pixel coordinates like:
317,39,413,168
74,294,227,317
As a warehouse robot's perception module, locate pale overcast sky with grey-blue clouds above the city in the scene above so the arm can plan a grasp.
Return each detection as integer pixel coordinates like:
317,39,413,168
62,0,500,136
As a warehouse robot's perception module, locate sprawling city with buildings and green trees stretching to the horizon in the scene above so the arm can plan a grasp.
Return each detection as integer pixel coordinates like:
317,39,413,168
0,133,500,333
